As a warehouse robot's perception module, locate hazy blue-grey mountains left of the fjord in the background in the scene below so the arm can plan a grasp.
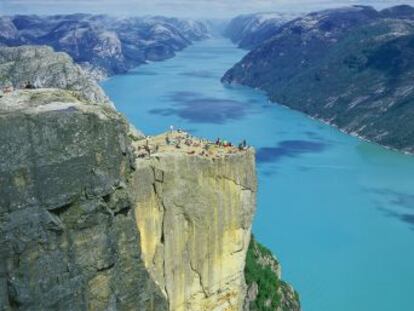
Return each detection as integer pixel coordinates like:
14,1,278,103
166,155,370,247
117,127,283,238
0,14,208,76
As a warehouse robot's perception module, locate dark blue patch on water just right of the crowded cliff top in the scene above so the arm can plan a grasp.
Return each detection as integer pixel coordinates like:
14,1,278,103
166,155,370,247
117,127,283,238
256,140,327,163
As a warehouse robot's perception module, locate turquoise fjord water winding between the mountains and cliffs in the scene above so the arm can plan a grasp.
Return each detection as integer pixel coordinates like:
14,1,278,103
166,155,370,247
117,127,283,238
103,39,414,311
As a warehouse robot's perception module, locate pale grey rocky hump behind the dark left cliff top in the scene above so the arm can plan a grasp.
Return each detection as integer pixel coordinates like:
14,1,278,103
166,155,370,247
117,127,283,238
0,46,112,105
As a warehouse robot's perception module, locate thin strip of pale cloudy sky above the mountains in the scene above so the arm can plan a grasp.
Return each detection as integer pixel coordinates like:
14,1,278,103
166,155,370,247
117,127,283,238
0,0,414,18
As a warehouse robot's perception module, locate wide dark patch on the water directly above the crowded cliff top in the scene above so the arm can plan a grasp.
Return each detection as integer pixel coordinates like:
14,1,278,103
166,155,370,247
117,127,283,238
149,92,248,124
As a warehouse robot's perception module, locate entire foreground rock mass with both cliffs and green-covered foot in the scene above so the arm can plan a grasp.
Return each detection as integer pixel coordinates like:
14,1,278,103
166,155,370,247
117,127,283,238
0,46,300,311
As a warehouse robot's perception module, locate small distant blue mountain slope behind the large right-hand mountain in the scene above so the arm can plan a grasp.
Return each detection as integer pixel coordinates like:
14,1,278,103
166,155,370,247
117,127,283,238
224,13,295,49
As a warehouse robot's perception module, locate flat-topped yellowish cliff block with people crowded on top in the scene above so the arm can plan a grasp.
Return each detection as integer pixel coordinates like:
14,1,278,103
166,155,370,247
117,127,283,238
134,137,256,311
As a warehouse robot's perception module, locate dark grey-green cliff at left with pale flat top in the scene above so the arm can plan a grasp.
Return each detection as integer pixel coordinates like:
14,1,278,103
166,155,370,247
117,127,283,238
0,90,167,311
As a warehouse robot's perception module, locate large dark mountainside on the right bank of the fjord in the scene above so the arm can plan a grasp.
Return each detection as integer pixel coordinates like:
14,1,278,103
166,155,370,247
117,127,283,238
222,6,414,153
